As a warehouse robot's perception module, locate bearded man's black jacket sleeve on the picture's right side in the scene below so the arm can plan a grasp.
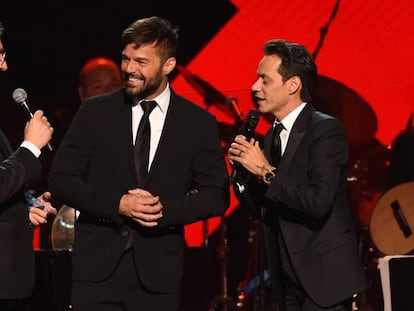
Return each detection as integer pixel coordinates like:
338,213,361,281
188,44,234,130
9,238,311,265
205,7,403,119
159,112,230,228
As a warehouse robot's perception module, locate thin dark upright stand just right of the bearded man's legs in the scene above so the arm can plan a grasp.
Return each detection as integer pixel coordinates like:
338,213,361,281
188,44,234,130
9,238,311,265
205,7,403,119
208,216,237,311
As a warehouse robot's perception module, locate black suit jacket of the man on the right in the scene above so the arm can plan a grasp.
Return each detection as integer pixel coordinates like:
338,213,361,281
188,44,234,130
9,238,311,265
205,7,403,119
243,104,365,307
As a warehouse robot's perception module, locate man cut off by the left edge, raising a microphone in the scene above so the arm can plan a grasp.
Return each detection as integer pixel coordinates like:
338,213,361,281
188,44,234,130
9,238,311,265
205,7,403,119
0,23,56,311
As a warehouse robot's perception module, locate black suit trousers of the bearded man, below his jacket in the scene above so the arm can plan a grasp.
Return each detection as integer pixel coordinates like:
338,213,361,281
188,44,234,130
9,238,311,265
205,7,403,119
72,247,180,311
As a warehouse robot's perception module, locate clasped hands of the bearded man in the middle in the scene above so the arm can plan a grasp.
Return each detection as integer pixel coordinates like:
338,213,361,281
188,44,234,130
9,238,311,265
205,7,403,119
119,188,163,227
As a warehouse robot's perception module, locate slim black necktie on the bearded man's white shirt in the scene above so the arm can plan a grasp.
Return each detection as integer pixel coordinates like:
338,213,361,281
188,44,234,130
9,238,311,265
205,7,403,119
135,100,157,186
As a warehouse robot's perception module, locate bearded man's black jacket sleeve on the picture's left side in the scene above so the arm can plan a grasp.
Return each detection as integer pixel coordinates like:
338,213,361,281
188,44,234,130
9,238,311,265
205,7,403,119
48,99,126,225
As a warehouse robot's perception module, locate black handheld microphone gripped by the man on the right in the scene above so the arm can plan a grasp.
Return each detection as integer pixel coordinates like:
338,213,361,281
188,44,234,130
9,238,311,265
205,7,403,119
231,109,260,192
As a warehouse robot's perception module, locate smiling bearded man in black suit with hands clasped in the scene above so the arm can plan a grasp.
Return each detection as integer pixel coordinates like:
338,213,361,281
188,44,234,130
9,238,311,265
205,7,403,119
49,17,229,311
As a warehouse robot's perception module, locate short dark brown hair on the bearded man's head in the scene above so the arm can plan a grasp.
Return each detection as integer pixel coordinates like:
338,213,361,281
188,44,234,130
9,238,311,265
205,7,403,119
121,16,178,60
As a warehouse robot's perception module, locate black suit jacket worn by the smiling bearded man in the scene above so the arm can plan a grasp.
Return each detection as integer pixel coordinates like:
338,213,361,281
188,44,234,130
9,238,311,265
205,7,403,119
49,90,229,292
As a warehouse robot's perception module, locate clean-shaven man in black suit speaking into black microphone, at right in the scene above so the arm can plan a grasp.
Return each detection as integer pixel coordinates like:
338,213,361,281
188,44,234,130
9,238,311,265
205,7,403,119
228,40,365,311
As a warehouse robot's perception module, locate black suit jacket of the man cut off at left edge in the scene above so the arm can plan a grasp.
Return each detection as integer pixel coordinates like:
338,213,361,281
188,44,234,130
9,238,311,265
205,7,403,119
0,130,41,299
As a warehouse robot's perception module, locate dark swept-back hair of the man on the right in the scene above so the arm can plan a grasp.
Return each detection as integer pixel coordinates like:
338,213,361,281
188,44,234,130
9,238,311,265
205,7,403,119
263,39,318,102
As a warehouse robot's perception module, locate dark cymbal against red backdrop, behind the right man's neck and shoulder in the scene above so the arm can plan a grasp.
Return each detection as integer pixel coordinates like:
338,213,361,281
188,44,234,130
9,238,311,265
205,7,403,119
312,76,378,148
